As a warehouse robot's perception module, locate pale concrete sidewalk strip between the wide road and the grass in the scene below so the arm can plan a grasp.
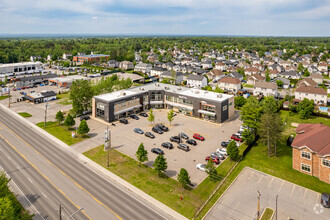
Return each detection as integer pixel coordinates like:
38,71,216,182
0,103,187,219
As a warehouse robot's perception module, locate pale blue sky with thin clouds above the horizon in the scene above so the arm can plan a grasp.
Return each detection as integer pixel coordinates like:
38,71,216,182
0,0,330,36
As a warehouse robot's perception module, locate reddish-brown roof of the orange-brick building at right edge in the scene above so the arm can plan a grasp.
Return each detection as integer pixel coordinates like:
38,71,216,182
291,124,330,156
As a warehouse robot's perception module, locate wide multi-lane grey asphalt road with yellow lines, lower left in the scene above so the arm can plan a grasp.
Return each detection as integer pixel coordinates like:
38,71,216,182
0,109,170,219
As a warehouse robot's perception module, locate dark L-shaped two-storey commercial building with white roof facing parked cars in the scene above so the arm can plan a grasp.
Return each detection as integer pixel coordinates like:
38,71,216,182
92,83,234,123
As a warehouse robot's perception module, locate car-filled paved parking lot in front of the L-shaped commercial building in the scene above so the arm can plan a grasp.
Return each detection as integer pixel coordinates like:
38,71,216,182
72,110,241,185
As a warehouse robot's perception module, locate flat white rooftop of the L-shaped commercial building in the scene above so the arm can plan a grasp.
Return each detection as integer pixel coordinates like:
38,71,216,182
95,83,233,102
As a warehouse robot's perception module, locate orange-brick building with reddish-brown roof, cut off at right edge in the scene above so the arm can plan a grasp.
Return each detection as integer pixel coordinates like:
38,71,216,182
291,124,330,184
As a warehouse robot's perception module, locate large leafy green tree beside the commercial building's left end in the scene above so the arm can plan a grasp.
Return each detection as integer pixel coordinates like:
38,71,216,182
70,79,94,114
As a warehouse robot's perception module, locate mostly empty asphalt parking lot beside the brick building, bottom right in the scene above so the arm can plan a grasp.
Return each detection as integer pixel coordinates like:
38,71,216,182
204,167,330,220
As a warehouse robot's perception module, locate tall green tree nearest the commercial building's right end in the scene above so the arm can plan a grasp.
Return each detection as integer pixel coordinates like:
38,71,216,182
241,97,262,136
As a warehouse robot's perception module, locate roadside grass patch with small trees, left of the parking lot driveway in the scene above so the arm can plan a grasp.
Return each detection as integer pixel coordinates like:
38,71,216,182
37,121,89,146
